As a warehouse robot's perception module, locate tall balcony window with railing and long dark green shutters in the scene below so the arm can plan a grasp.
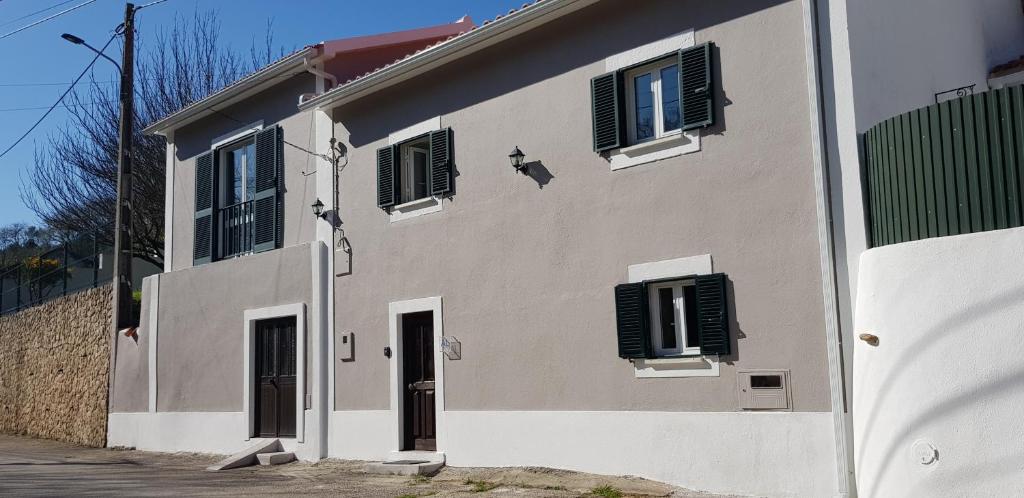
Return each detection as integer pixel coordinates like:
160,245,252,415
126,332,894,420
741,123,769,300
194,126,284,264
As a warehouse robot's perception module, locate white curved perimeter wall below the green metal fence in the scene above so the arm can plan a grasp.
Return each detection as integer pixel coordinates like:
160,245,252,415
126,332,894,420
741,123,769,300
853,229,1024,498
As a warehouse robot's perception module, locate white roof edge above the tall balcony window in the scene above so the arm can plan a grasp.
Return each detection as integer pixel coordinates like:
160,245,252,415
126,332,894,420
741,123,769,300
142,45,321,136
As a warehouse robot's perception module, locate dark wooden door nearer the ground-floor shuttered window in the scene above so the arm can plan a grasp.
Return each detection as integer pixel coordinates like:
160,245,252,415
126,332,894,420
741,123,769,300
401,312,437,451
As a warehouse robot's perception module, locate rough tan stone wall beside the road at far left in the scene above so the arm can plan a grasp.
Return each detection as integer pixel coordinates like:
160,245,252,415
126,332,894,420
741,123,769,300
0,285,111,447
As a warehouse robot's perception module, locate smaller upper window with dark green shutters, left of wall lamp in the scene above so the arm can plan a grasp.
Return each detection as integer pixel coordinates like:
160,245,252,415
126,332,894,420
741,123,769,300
377,128,455,211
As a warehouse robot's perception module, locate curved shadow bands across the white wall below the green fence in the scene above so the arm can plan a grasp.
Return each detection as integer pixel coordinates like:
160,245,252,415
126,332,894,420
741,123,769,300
854,286,1024,496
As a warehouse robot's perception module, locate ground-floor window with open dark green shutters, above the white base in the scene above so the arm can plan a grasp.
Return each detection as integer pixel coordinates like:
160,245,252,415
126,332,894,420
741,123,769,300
615,274,732,359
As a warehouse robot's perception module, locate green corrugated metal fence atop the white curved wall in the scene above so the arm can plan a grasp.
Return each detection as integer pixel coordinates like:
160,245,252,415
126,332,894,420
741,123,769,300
864,86,1024,247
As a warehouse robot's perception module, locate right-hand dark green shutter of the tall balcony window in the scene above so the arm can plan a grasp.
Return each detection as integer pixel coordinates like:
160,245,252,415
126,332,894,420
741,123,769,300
253,125,284,252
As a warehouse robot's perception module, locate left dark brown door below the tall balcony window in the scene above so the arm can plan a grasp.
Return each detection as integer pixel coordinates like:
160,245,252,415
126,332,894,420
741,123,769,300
253,317,297,438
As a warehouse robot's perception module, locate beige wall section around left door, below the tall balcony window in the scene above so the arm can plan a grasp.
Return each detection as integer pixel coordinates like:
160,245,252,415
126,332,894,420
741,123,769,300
150,244,312,412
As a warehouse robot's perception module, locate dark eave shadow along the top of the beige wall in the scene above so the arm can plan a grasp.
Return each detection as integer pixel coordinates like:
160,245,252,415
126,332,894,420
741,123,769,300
334,0,784,147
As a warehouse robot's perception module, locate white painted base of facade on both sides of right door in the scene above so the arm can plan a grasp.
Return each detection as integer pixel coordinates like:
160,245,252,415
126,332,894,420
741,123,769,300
329,410,836,498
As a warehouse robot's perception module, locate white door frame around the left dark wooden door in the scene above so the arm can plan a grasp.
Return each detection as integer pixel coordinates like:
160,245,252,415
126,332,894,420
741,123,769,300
242,302,306,443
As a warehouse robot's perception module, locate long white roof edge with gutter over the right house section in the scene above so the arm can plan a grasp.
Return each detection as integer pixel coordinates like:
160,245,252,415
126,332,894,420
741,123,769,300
299,0,598,111
